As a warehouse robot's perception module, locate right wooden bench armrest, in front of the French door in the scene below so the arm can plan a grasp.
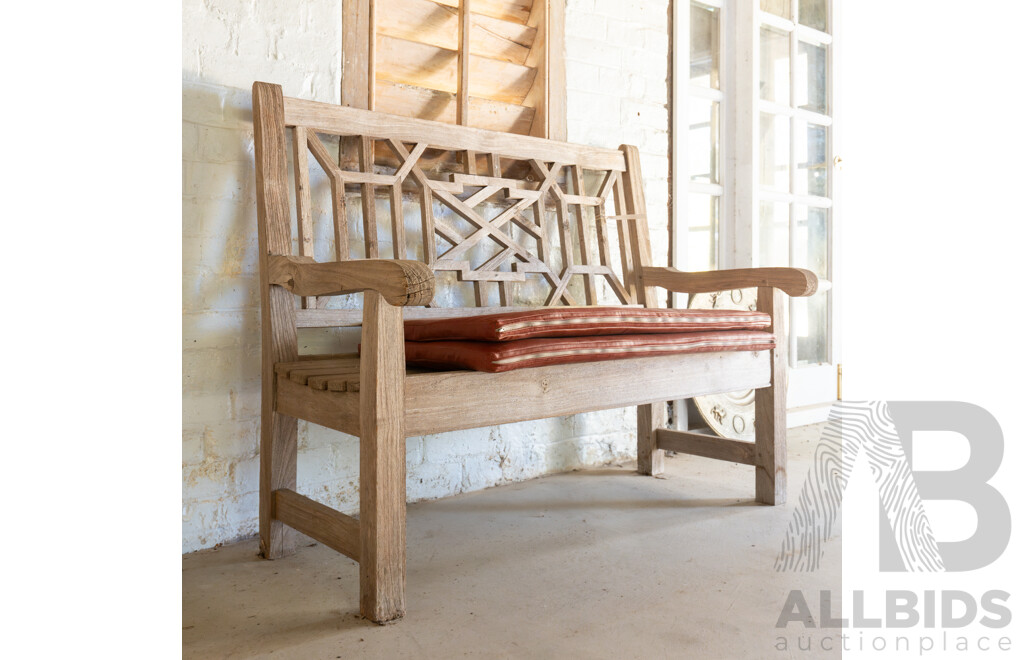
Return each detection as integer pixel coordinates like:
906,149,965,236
643,266,825,296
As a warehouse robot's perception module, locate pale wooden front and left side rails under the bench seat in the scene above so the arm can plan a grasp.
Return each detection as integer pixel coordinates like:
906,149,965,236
275,351,769,437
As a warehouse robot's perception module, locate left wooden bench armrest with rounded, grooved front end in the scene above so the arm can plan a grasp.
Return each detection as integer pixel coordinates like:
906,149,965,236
267,255,434,307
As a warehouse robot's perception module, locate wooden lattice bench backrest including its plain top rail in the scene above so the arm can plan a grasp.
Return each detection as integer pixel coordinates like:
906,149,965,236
285,98,646,308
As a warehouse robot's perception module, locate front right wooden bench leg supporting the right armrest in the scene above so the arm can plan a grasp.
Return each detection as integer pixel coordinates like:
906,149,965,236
754,287,787,504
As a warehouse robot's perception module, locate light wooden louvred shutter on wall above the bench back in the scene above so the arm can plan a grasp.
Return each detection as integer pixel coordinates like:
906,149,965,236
342,0,565,140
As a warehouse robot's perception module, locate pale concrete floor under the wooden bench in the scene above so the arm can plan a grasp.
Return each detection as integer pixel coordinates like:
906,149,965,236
182,426,842,660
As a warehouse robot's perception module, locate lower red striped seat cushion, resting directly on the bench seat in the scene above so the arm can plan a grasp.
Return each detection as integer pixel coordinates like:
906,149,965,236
406,331,775,370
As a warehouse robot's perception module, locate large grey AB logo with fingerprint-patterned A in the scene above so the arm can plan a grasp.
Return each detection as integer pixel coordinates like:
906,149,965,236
775,401,1010,572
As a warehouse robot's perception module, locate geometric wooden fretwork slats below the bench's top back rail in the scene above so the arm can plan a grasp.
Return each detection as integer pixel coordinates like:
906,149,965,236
293,126,637,307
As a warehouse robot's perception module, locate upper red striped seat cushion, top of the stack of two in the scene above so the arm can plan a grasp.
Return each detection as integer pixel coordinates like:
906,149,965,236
406,307,771,342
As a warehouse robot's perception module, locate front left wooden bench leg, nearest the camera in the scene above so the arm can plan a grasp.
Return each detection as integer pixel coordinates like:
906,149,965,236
359,291,406,623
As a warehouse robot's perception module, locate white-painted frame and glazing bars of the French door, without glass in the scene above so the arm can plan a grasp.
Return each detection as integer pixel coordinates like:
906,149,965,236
670,0,842,426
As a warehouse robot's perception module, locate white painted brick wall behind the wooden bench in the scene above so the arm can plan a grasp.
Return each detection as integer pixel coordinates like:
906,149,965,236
181,0,669,552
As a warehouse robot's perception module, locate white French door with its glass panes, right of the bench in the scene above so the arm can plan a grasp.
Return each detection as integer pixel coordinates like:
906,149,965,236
673,0,839,419
